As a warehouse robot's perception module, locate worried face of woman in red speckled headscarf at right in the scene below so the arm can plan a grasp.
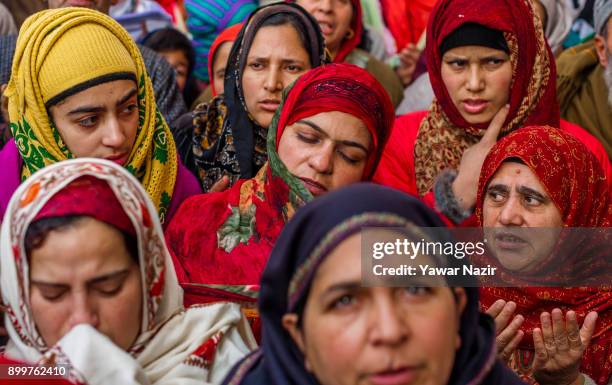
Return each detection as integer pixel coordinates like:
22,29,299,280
482,162,563,271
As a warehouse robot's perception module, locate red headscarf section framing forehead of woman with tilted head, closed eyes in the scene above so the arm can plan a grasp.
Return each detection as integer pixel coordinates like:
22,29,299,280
276,64,395,179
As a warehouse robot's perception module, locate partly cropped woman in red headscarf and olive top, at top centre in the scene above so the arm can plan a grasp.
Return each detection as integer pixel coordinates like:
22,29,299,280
293,0,404,106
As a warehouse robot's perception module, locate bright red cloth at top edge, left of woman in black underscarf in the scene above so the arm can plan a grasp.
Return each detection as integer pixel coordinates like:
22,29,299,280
380,0,437,52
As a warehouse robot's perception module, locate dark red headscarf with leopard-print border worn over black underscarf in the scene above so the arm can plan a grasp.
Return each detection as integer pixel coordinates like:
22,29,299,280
414,0,560,195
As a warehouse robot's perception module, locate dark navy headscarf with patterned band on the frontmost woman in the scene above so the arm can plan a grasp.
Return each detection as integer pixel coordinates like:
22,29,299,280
224,183,523,385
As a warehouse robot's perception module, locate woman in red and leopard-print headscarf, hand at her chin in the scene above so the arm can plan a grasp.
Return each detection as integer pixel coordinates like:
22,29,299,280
374,0,612,222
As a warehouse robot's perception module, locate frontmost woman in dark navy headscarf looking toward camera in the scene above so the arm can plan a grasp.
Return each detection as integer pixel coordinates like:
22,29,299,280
225,184,523,385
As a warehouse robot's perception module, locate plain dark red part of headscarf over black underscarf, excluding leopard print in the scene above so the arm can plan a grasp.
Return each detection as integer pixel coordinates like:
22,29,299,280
425,0,560,132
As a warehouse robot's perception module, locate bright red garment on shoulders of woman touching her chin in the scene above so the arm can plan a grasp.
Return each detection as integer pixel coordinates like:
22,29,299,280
373,111,612,195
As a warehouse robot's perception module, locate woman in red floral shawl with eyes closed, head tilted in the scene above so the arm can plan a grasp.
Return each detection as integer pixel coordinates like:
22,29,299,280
166,64,394,332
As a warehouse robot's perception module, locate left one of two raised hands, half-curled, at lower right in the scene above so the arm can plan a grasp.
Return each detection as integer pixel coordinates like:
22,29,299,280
486,299,525,362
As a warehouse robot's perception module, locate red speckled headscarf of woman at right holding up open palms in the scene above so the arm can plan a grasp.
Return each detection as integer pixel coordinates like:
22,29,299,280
476,127,612,385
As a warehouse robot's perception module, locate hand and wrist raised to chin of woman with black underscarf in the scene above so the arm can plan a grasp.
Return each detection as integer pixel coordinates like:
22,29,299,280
453,105,510,211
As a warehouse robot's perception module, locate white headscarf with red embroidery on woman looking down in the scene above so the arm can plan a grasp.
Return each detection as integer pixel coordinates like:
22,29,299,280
0,158,256,385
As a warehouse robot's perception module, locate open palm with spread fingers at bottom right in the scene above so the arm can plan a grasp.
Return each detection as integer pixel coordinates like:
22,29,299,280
533,309,597,385
